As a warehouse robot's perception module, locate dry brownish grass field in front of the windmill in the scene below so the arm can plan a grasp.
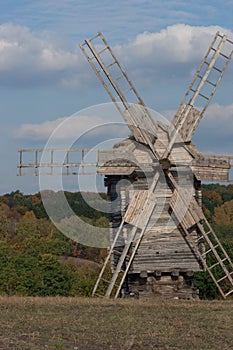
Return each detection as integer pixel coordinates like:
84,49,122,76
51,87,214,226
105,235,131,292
0,297,233,350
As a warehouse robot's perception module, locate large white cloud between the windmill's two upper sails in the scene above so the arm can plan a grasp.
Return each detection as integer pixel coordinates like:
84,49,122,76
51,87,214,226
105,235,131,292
116,24,233,83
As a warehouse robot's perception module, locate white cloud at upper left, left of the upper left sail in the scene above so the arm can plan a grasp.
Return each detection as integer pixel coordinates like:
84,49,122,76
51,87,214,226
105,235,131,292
0,24,82,86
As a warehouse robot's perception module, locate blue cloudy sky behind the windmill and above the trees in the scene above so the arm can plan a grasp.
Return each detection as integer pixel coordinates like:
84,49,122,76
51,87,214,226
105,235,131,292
0,0,233,194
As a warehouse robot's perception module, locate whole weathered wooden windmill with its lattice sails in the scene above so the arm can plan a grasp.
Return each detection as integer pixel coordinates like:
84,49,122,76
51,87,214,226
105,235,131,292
19,32,233,299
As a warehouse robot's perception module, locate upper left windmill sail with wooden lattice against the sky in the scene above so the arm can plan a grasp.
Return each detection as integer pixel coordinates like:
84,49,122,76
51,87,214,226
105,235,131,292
80,33,158,157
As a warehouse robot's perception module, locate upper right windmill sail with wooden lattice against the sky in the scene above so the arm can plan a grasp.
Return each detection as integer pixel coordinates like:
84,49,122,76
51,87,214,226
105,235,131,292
166,32,233,153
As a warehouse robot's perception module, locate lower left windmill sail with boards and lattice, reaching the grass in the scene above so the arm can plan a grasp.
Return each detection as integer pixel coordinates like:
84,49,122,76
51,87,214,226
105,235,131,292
92,172,160,299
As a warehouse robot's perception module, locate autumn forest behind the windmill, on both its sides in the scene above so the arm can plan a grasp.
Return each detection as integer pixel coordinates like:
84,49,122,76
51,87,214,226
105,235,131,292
0,184,233,299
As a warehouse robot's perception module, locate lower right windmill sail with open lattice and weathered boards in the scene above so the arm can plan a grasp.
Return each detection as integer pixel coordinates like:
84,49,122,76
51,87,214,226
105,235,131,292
168,173,233,299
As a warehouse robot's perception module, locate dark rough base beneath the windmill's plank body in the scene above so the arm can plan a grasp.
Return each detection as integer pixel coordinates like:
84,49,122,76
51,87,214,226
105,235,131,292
122,271,199,299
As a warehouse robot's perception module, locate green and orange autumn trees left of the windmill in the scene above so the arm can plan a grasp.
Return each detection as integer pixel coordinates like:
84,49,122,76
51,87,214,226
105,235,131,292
0,191,108,296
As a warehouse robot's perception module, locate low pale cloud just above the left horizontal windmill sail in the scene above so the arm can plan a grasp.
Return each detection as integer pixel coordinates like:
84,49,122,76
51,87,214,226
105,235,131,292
14,103,129,147
